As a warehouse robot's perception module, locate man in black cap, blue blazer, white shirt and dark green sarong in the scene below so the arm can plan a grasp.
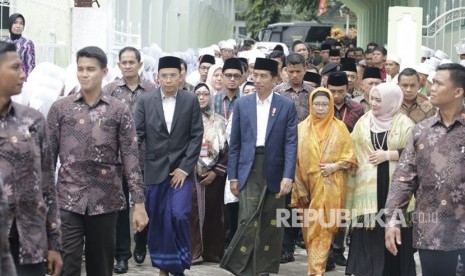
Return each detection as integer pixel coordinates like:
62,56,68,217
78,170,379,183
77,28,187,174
221,58,297,275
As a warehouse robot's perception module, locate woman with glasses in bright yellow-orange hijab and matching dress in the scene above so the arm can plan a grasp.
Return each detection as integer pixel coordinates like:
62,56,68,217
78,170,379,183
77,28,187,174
291,87,355,275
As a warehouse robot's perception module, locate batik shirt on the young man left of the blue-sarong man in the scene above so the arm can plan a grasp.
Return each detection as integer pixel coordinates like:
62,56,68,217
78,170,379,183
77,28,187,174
48,92,144,216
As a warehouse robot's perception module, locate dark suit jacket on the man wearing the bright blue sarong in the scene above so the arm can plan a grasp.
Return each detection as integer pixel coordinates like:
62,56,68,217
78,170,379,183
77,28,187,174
134,89,203,185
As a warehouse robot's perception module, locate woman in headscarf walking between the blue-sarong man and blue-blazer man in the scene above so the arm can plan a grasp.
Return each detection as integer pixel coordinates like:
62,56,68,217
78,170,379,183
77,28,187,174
190,83,228,264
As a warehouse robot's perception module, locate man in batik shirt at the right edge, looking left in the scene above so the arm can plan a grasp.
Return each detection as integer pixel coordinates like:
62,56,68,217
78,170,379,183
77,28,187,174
385,63,465,276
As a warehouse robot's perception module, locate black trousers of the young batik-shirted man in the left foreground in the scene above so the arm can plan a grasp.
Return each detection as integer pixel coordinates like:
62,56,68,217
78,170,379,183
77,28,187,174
61,210,118,276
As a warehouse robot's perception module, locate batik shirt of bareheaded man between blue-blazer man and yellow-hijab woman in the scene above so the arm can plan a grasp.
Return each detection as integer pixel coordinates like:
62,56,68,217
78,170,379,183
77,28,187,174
273,81,314,123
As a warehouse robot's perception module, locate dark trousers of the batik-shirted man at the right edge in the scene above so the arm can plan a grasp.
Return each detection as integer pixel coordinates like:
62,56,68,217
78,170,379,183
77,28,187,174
418,249,465,276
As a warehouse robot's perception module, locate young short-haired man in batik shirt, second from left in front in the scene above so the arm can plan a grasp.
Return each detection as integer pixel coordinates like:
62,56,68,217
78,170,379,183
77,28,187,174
47,46,148,276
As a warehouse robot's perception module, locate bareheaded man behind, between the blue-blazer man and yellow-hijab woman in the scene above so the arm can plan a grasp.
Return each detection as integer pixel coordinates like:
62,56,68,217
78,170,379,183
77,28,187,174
273,53,313,263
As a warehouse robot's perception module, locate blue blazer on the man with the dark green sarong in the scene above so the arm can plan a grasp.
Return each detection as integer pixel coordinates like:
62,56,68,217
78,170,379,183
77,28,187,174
228,93,297,193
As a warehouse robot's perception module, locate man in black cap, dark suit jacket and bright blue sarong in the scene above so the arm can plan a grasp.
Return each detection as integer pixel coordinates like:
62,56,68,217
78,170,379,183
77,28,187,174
135,56,203,276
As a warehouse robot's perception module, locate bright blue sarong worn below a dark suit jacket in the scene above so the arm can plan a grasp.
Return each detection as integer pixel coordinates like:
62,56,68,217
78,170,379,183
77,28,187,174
145,177,192,273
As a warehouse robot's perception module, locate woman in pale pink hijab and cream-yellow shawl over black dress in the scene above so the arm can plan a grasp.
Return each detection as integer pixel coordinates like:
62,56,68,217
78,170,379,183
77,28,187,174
346,83,416,276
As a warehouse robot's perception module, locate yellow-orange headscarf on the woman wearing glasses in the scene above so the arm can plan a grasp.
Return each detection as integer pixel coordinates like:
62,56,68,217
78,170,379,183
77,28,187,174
308,87,334,141
